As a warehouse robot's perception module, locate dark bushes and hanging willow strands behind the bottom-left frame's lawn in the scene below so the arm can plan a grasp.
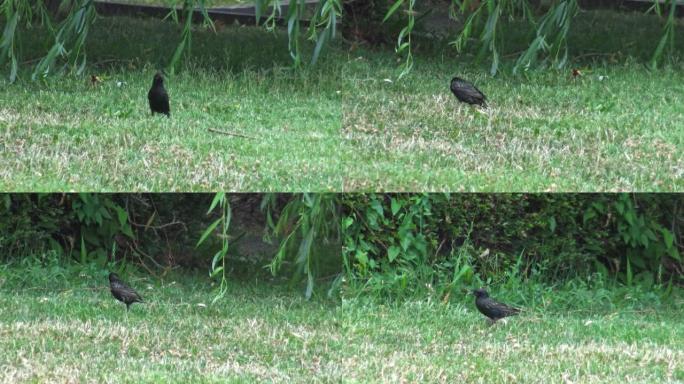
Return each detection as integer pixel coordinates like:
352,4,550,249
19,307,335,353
0,193,341,299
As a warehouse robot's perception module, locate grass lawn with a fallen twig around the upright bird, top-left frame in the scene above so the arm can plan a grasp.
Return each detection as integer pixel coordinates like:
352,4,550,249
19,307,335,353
0,18,343,192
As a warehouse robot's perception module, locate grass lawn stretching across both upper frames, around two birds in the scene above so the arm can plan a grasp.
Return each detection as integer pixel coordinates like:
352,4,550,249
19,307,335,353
0,11,684,192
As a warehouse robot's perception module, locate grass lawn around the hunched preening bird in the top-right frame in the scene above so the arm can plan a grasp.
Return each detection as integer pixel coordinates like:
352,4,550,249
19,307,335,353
342,11,684,191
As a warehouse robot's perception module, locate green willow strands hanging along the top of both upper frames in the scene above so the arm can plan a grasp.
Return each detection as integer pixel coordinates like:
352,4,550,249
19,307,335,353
0,0,678,82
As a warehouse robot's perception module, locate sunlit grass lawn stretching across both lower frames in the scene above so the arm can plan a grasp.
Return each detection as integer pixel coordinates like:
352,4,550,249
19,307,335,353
0,275,684,383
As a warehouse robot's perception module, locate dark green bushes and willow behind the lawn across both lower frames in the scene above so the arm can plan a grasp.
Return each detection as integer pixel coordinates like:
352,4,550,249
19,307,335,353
0,193,684,299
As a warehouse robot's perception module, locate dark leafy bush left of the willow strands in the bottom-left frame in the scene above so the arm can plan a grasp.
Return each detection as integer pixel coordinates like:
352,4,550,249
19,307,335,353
0,193,211,267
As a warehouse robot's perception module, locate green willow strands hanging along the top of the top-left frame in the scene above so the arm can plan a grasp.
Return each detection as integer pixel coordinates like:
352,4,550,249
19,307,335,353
0,0,342,82
